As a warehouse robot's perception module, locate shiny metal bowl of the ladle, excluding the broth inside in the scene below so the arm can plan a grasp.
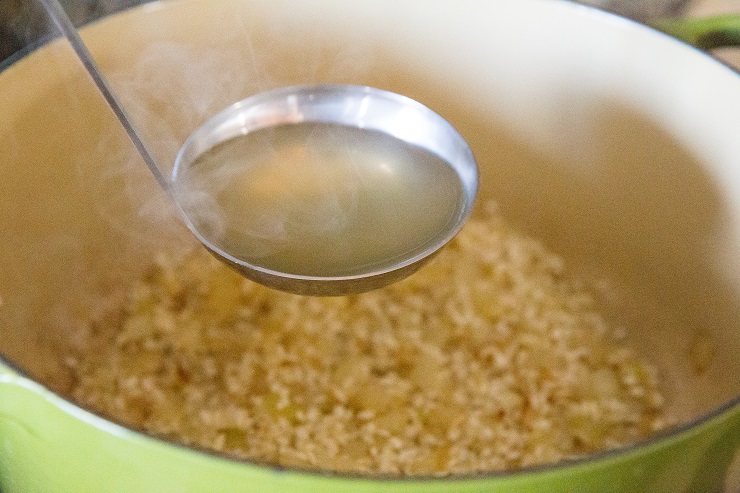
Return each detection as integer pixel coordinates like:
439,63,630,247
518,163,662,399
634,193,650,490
172,85,478,296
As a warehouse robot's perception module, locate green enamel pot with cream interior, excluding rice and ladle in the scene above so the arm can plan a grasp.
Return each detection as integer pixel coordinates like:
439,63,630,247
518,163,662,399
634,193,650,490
0,0,740,493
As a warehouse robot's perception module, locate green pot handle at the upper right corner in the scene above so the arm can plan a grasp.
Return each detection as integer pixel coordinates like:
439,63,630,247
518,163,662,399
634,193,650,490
653,14,740,50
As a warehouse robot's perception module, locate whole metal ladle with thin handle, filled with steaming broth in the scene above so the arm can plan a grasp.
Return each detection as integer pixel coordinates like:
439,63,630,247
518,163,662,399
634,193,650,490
40,0,478,295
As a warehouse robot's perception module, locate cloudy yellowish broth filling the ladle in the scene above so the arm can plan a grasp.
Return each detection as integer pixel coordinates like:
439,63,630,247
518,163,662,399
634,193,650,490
176,123,463,277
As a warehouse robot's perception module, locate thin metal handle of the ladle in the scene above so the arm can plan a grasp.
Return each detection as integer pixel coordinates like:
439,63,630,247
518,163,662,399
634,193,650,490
39,0,170,193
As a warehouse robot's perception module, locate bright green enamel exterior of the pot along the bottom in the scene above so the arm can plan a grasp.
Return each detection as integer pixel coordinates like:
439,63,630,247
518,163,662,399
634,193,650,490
0,365,740,493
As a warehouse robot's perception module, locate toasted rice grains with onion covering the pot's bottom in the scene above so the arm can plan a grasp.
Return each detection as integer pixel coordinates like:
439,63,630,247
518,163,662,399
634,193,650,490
60,202,671,475
